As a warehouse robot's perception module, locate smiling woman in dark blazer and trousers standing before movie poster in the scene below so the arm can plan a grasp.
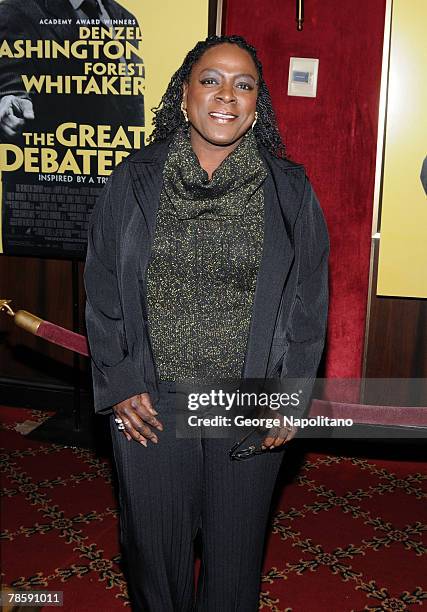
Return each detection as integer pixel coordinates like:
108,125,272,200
85,36,328,612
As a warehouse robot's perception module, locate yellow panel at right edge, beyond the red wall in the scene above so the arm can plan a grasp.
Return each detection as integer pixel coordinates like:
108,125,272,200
377,0,427,298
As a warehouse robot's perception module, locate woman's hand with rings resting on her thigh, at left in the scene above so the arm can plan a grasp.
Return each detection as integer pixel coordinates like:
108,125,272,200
113,393,163,446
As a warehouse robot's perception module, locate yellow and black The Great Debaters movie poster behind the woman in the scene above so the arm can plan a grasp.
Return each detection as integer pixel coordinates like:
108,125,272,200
0,0,208,259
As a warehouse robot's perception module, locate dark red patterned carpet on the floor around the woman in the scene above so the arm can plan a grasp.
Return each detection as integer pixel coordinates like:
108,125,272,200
0,408,427,612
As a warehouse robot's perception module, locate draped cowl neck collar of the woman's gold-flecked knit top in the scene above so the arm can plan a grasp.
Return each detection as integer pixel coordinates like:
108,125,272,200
163,129,267,219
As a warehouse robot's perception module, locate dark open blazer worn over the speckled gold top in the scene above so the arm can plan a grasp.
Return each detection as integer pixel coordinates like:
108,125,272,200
84,140,329,412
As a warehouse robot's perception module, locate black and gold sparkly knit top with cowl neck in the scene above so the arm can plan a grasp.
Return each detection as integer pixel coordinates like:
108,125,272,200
147,130,267,382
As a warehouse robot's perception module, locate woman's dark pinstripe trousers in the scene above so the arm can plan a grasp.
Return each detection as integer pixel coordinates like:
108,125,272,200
110,382,283,612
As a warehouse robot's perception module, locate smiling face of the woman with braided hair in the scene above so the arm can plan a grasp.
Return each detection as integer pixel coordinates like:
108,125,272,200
183,43,258,146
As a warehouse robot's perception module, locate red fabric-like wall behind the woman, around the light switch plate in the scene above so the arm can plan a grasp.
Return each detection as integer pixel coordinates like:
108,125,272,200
225,0,385,377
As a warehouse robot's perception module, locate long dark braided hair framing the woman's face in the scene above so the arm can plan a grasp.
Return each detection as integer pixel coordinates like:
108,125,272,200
149,35,286,158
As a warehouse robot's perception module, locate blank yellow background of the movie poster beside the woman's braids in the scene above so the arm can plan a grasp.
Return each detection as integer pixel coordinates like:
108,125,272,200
119,0,209,138
